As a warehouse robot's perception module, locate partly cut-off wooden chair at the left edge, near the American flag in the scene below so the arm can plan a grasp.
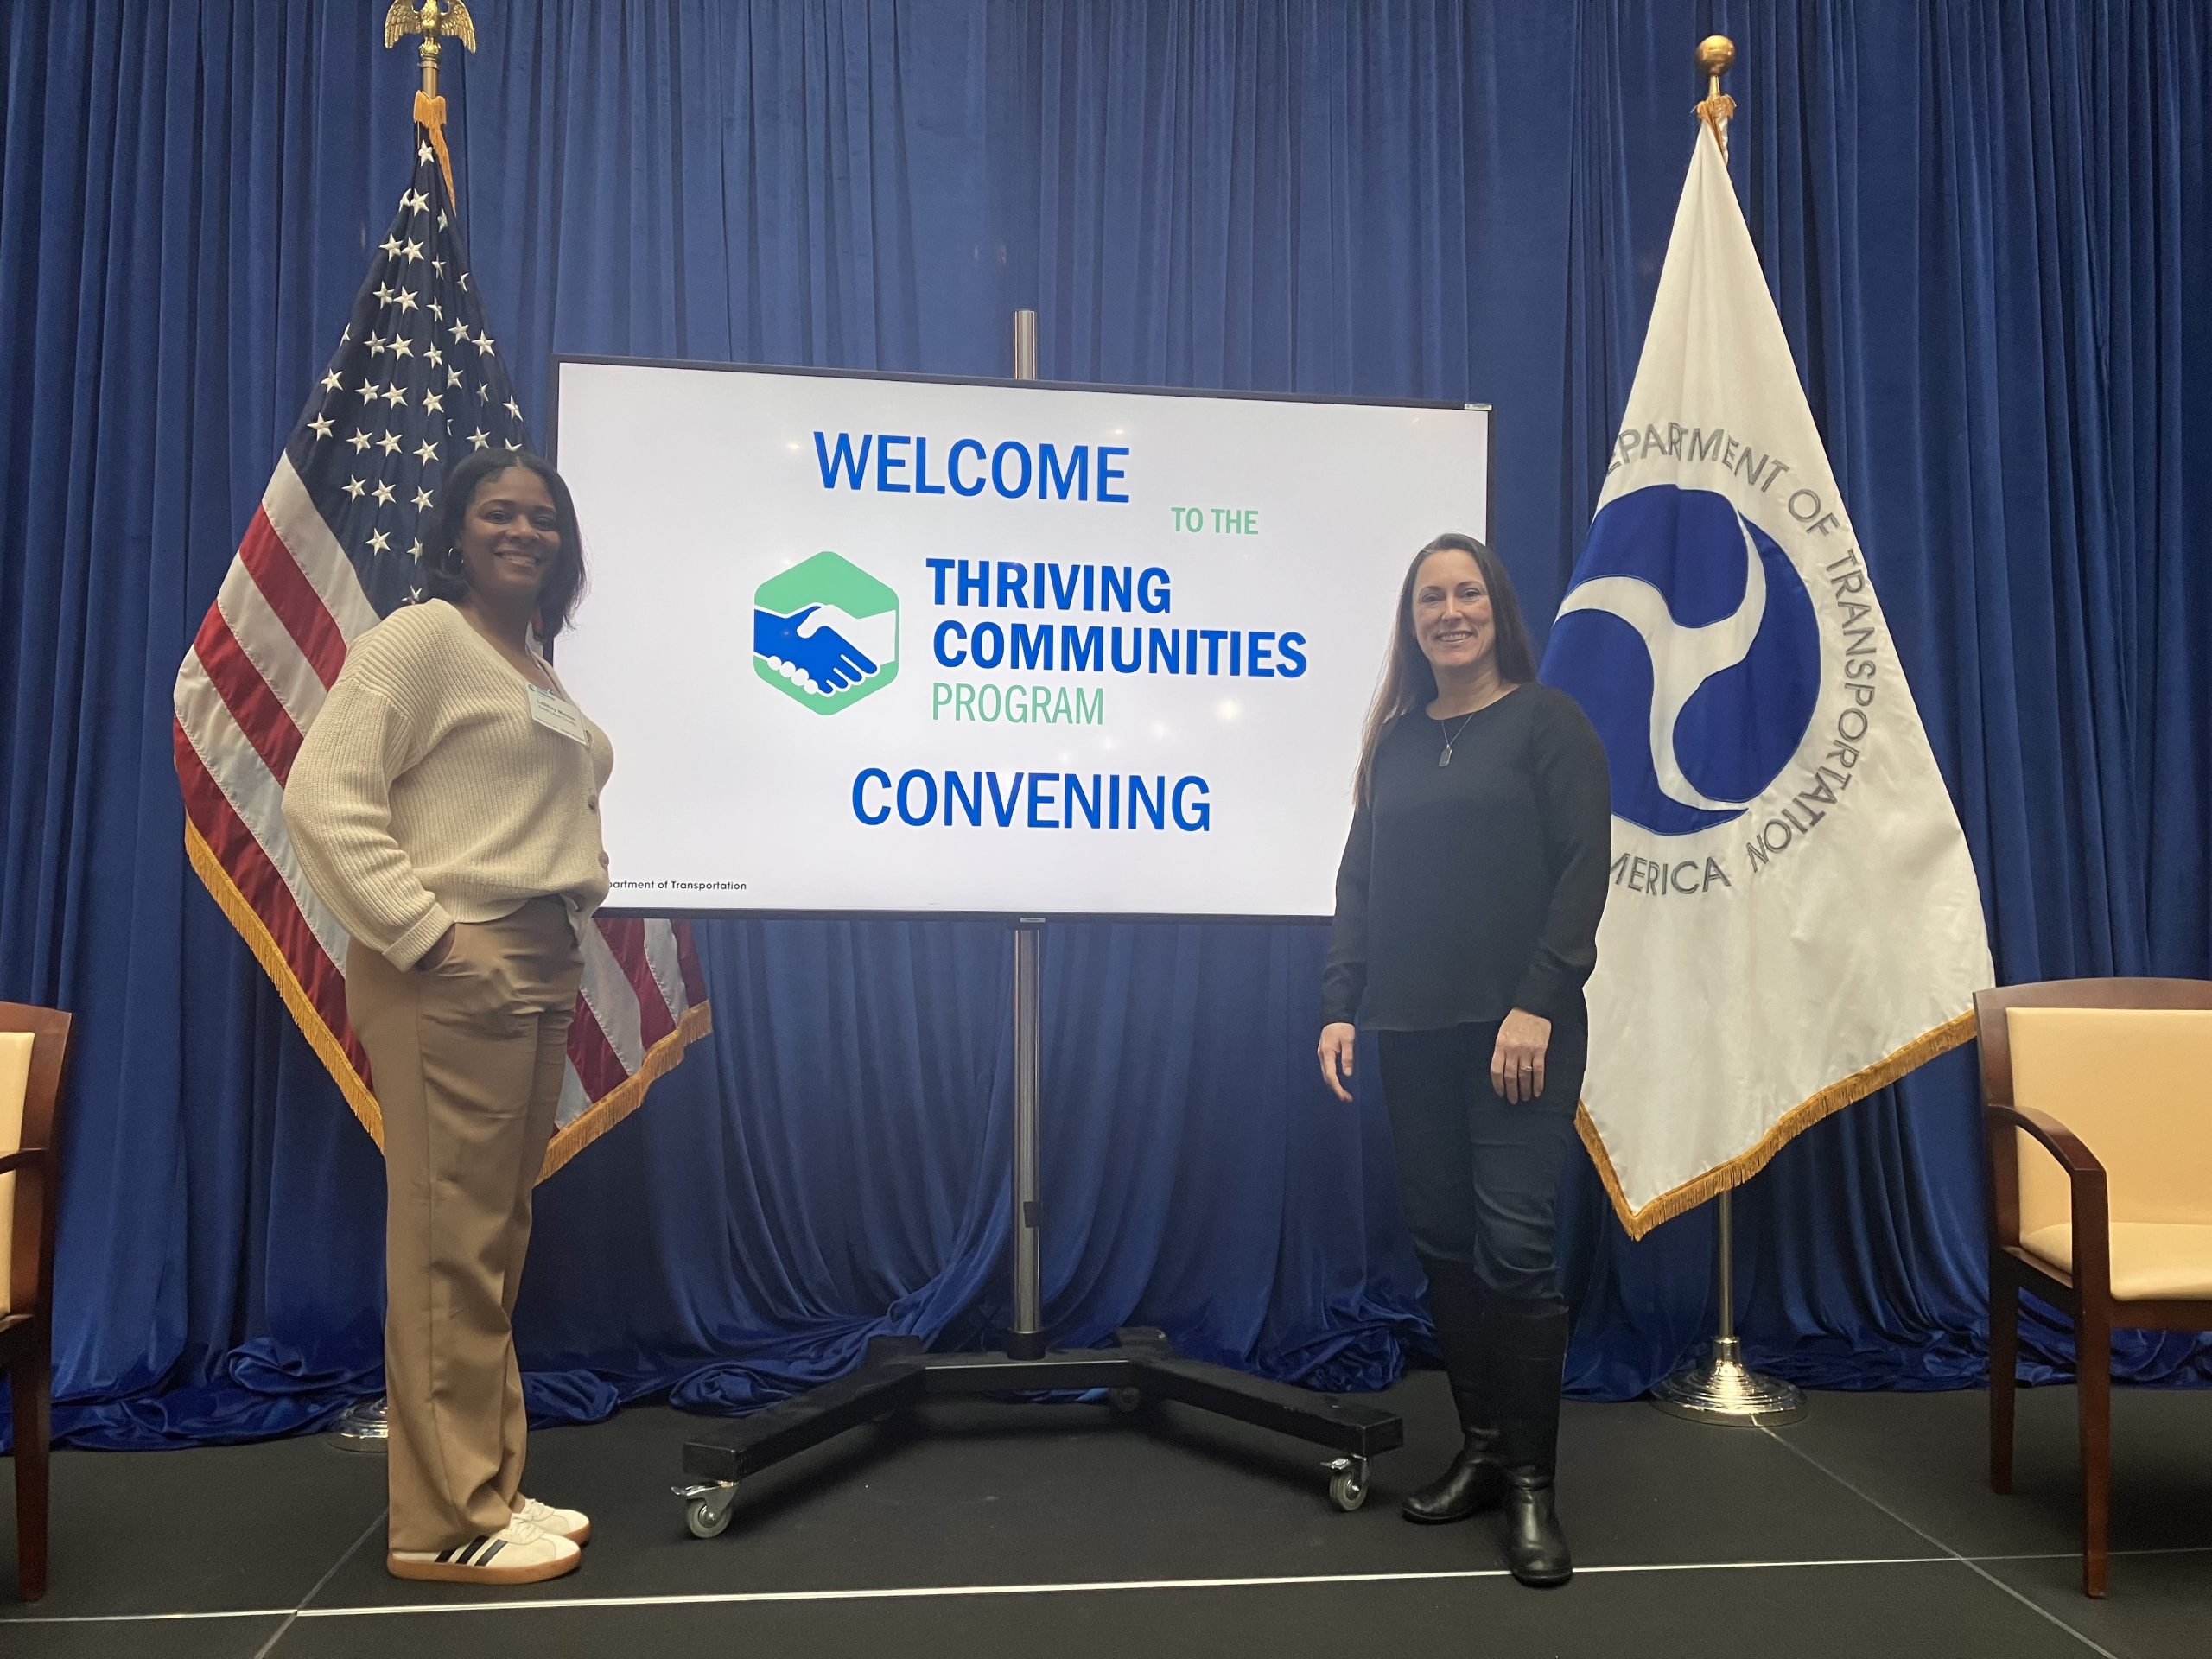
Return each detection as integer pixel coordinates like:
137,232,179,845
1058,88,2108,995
0,1002,68,1601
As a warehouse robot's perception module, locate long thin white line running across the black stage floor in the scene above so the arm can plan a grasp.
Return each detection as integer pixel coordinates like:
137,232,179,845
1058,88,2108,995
0,1557,2212,1628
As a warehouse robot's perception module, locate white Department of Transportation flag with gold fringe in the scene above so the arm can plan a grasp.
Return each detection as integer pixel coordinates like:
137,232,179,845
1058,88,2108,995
1541,124,1993,1239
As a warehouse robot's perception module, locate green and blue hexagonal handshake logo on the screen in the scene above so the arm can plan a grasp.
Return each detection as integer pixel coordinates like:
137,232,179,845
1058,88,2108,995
752,553,898,715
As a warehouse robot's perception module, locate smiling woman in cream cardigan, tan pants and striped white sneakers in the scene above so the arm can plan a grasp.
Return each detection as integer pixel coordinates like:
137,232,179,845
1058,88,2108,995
285,449,615,1584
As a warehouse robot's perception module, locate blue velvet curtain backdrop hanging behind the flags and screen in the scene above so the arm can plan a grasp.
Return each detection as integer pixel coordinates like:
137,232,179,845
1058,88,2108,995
0,0,2212,1445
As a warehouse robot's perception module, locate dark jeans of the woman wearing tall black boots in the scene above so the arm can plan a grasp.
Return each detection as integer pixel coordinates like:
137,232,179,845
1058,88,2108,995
1378,1020,1588,1303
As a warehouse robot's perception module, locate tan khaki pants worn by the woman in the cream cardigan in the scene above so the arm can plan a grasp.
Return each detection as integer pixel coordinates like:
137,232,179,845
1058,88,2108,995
345,898,584,1551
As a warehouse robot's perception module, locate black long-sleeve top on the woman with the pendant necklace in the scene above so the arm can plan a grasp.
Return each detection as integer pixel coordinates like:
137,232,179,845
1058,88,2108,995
1320,683,1612,1031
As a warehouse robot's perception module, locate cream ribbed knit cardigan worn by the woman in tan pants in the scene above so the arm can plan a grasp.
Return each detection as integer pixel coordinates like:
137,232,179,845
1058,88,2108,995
283,600,615,969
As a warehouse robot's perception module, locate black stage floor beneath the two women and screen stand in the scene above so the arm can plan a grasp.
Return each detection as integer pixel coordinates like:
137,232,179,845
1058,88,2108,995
0,1371,2212,1659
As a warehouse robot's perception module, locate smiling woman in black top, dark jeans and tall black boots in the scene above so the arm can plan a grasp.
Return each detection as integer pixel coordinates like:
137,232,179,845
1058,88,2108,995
1320,536,1612,1584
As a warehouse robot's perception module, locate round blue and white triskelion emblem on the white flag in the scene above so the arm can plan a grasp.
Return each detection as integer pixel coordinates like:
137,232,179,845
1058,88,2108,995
1544,485,1821,836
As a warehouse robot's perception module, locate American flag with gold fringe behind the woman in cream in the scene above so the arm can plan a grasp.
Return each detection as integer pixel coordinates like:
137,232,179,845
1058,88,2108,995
173,99,710,1179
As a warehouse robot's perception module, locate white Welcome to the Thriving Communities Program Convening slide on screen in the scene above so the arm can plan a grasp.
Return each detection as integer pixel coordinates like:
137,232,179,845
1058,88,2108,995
553,359,1491,916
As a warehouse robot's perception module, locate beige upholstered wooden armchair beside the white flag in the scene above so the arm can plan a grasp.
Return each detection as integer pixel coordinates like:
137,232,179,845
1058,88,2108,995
1974,980,2212,1595
